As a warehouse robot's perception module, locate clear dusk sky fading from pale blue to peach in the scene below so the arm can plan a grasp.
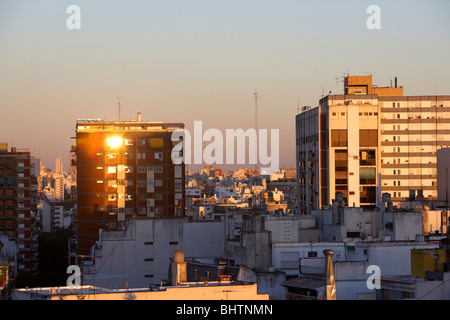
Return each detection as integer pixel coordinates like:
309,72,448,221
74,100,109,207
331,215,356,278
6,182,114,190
0,0,450,169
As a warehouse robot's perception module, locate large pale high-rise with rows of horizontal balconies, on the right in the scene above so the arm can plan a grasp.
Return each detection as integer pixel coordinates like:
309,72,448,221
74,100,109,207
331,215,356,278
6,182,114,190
296,75,450,212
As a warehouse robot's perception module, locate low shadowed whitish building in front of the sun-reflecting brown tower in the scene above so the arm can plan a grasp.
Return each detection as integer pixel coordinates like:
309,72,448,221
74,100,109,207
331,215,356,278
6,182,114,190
82,218,224,289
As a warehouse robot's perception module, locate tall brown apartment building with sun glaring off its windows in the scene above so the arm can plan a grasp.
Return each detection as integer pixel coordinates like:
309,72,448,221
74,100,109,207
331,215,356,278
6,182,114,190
75,113,185,253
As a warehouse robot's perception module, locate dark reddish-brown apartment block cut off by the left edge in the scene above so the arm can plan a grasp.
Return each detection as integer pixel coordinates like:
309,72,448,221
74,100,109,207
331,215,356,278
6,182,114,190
0,143,37,273
